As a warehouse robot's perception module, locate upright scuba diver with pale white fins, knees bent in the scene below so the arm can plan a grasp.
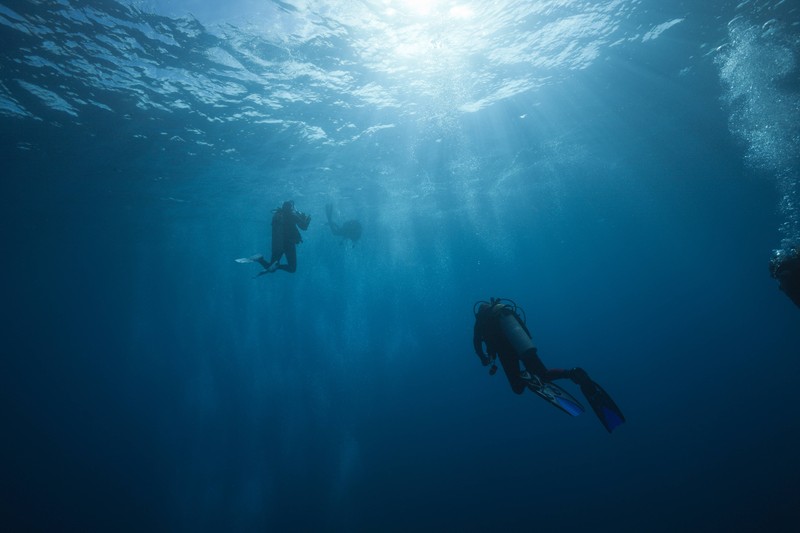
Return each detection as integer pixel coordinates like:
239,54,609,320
236,200,311,276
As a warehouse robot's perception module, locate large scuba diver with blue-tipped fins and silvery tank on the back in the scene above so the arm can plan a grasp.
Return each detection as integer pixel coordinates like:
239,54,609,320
472,298,625,433
